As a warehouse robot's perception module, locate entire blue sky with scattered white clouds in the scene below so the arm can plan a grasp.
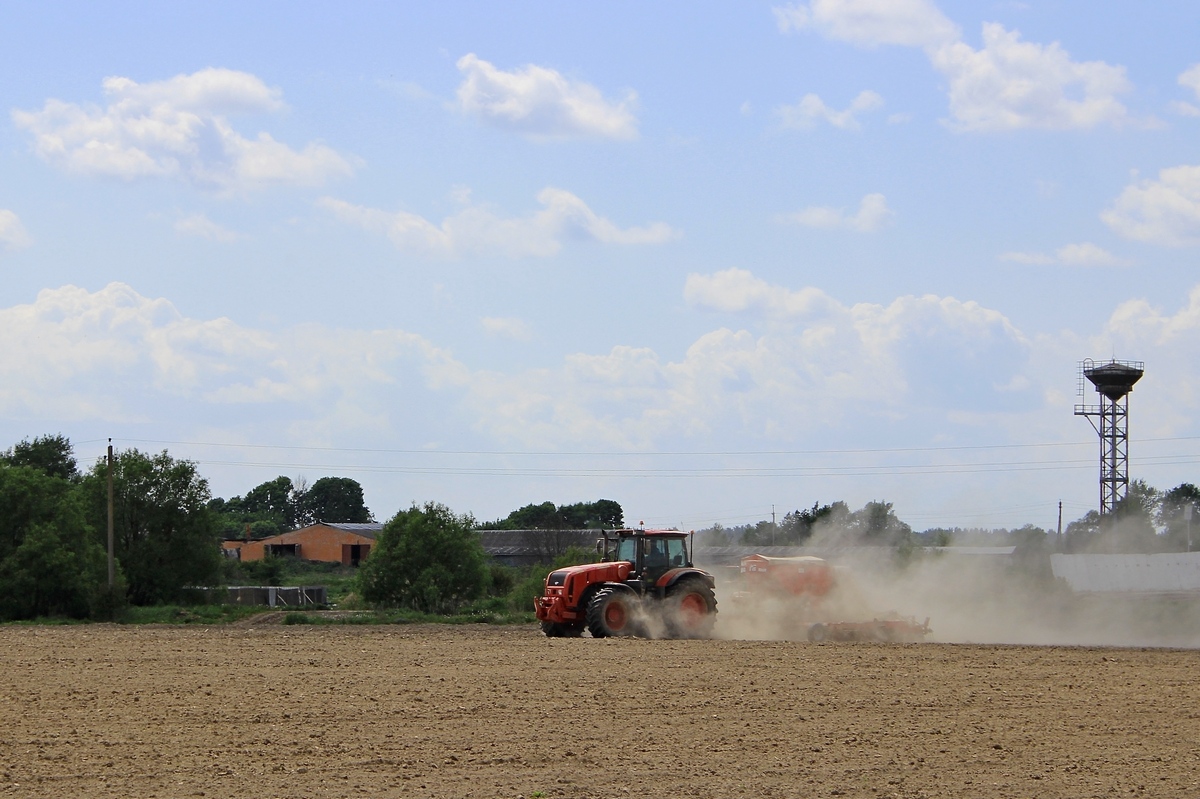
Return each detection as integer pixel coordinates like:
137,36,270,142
0,0,1200,530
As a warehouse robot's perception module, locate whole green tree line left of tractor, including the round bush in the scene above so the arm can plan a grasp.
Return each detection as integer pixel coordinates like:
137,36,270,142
0,434,623,620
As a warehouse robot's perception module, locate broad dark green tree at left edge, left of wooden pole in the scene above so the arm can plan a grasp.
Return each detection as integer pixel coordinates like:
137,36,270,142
0,463,108,619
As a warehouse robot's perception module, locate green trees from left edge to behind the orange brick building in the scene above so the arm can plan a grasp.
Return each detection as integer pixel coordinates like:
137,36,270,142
0,434,372,620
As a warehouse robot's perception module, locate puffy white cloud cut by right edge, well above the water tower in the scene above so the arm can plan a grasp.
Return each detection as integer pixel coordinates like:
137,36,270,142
1100,166,1200,247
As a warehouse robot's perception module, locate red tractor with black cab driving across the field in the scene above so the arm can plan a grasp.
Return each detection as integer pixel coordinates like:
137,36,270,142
534,529,716,638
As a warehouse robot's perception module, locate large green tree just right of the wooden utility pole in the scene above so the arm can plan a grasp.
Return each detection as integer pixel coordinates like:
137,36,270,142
83,450,221,605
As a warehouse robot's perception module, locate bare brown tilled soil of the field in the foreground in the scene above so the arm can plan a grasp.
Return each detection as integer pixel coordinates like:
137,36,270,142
0,625,1200,799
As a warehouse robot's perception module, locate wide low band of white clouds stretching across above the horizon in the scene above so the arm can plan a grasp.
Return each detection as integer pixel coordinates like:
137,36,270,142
9,269,1200,482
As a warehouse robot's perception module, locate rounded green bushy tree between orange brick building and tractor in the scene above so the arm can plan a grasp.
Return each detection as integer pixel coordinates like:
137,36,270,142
359,503,490,613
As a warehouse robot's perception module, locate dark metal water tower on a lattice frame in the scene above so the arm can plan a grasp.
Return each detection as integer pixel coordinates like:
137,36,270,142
1075,359,1145,516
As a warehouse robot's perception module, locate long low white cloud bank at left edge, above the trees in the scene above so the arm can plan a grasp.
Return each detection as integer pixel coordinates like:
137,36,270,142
0,283,461,423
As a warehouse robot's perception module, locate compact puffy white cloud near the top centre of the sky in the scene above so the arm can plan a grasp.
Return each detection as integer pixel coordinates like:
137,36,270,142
457,53,637,139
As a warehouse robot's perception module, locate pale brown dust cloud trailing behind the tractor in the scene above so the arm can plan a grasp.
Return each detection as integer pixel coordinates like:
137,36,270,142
709,515,1200,648
